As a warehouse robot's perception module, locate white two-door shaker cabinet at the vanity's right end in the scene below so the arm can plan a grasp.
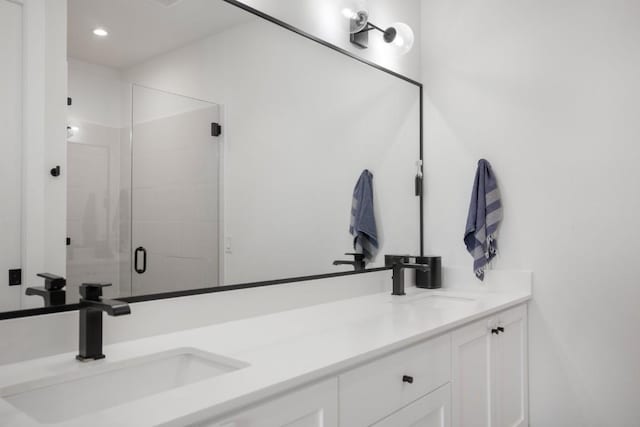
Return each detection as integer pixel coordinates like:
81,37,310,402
451,305,528,427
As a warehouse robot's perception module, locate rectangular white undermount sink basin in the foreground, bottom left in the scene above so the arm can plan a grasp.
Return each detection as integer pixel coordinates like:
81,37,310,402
0,348,249,424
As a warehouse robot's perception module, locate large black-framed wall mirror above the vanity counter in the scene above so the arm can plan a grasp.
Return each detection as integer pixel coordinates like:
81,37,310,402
0,0,421,311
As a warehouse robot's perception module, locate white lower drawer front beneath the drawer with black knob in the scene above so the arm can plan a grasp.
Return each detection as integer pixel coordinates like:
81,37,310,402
374,384,451,427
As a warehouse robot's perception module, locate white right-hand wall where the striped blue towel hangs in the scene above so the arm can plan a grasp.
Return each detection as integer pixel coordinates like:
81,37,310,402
422,0,640,427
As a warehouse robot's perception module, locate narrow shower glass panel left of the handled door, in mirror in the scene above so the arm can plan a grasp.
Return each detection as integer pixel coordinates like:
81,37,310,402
66,130,122,303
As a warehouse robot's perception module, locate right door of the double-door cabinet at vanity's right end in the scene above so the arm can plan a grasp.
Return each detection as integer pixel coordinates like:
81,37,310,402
494,306,528,427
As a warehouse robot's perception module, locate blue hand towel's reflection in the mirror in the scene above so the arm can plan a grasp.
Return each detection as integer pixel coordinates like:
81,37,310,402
349,169,378,261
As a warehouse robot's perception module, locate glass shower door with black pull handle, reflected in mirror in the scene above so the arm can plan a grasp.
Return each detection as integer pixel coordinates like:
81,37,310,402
131,85,222,295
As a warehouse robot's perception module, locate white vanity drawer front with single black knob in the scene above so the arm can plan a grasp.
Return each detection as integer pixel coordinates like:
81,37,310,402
339,334,451,427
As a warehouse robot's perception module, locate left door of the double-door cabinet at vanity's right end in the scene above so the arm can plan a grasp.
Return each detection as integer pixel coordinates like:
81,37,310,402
451,319,494,427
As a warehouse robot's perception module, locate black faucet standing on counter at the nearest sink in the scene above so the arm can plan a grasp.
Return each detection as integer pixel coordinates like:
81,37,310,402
76,283,131,362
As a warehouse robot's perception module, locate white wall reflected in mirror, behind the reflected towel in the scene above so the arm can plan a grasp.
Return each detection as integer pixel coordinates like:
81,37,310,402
124,19,419,283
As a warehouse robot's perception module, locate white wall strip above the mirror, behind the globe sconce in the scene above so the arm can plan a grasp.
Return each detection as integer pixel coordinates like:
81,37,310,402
242,0,421,80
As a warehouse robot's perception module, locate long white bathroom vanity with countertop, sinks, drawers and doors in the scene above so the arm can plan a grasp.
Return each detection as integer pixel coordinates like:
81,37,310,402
0,288,530,427
